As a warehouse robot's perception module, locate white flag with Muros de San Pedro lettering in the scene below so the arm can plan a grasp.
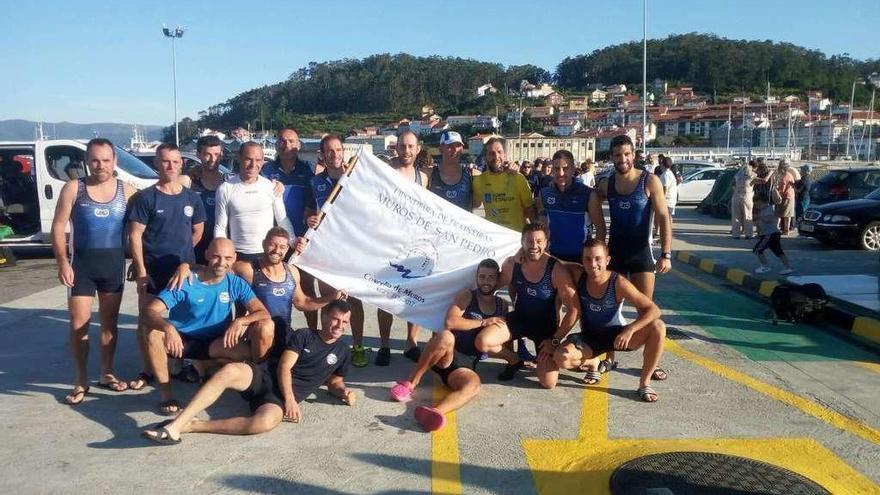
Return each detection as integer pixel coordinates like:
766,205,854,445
292,150,520,331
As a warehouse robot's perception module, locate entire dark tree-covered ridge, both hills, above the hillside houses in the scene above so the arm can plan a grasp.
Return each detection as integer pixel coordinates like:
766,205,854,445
186,33,880,133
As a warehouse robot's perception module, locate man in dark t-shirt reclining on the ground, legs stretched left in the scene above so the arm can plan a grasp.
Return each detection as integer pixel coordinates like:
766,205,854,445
144,299,355,445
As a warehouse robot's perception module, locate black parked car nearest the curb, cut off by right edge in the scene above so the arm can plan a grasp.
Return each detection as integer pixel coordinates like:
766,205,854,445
798,189,880,251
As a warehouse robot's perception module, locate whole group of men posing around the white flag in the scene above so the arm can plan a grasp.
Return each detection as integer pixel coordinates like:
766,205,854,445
52,128,671,444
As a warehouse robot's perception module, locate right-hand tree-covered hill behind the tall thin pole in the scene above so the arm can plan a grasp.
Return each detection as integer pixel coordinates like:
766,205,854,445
556,33,880,99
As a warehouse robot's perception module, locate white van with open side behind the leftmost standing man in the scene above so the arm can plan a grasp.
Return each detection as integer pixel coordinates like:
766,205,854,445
0,139,159,247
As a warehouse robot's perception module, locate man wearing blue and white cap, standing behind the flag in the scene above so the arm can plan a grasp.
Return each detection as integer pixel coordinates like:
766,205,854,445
428,131,479,211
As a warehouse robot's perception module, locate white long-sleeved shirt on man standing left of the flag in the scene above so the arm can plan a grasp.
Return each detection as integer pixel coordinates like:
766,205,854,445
214,175,293,254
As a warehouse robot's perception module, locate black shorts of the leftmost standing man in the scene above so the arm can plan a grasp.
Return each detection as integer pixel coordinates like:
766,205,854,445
70,249,125,297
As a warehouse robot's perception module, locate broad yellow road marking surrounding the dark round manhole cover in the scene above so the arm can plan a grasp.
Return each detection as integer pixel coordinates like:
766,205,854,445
522,375,877,495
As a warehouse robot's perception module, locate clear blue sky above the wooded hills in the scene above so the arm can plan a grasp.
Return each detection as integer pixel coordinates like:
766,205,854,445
0,0,880,125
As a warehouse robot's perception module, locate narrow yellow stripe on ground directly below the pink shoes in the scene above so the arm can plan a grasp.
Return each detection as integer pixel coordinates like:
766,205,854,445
431,380,461,495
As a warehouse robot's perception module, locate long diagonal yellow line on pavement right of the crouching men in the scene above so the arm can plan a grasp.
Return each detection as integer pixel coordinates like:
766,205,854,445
666,340,880,445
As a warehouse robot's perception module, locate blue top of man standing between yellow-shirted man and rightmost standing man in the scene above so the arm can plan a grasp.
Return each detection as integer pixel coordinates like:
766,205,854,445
541,181,592,258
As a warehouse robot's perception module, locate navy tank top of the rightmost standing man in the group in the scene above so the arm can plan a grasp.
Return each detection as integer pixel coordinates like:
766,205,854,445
608,170,652,244
